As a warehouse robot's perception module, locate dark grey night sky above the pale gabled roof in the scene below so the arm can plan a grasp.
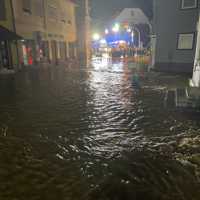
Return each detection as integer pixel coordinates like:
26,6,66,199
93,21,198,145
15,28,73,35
91,0,152,28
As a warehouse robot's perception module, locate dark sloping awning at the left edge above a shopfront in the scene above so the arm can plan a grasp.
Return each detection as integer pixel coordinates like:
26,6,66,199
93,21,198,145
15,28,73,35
0,26,22,41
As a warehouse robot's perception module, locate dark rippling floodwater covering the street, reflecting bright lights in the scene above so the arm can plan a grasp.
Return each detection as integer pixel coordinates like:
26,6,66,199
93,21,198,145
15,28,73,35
0,59,200,200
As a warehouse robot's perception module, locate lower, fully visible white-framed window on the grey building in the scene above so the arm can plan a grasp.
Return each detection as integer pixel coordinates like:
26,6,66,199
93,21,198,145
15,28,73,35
178,33,194,50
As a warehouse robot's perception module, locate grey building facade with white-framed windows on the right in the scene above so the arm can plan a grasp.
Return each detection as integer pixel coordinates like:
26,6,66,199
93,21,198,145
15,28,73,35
152,0,200,73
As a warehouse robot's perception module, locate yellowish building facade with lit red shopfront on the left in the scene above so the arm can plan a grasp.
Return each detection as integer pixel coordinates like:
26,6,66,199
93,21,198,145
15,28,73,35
0,0,77,70
